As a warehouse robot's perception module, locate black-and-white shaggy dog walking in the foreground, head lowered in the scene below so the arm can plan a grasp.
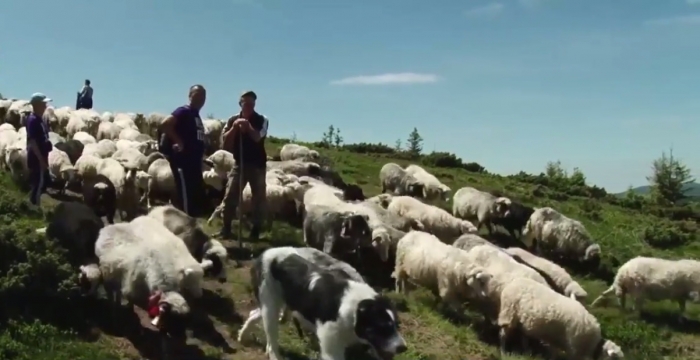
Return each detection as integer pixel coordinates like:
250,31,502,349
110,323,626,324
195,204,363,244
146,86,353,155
239,247,407,360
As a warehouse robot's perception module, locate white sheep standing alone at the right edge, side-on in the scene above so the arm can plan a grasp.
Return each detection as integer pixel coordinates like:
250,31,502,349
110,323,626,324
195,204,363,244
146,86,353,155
591,256,700,320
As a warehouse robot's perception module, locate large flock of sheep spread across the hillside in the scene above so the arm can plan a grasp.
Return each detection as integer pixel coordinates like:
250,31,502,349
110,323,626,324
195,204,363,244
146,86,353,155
0,96,700,359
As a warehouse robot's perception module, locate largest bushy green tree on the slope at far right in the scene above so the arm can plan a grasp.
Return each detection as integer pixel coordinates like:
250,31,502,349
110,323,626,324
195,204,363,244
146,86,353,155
647,149,695,204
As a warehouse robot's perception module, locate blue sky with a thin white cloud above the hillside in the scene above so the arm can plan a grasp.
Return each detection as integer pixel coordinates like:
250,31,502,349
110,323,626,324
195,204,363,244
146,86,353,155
0,0,700,191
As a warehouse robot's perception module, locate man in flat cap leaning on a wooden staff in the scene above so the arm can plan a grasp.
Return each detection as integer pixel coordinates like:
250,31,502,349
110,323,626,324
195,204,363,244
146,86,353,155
213,91,269,240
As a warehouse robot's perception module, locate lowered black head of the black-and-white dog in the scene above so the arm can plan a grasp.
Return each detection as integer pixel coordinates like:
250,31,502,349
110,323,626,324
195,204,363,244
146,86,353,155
355,295,407,360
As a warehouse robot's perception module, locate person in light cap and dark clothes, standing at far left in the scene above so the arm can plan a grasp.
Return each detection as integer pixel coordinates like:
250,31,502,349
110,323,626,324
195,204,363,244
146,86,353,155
26,93,53,205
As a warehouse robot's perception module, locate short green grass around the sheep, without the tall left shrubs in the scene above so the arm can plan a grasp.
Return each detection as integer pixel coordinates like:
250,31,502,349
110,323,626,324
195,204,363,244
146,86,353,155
0,136,700,360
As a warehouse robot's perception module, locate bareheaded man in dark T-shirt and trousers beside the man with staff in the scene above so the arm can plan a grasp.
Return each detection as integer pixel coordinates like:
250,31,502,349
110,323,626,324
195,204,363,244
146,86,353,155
159,85,207,217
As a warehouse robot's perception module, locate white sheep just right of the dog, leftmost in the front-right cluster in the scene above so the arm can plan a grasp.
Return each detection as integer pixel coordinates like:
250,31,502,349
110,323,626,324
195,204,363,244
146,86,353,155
391,231,491,306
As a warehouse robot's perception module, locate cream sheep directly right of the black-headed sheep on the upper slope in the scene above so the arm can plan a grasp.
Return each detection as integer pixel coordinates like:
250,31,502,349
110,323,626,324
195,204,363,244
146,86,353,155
523,207,601,261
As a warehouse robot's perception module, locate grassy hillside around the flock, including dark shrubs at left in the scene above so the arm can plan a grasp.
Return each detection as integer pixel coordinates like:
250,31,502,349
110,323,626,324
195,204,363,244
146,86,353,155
0,139,700,360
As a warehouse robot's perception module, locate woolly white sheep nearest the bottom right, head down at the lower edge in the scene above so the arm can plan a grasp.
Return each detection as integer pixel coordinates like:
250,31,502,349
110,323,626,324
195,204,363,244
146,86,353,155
498,279,624,360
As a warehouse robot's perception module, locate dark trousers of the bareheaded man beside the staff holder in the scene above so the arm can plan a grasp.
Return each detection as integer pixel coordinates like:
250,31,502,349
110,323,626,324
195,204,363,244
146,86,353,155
170,160,205,217
